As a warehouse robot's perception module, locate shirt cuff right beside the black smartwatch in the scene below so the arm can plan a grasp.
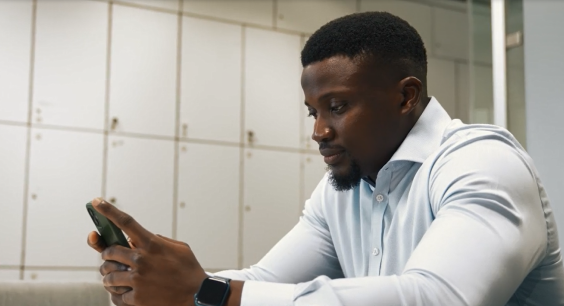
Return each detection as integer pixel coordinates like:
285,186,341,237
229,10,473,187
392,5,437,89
241,281,296,306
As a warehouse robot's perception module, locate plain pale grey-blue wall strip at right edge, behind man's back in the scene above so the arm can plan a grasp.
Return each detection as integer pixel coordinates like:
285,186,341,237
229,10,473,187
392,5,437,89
523,1,564,246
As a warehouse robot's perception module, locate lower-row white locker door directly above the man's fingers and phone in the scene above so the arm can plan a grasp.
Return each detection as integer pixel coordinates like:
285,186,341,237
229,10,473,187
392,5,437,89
106,136,174,237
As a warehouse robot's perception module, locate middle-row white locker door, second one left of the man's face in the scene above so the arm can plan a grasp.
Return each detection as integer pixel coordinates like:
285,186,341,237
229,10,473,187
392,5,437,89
179,17,241,142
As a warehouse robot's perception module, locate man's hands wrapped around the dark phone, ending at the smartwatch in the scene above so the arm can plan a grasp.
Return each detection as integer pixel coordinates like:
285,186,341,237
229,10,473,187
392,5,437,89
88,199,207,306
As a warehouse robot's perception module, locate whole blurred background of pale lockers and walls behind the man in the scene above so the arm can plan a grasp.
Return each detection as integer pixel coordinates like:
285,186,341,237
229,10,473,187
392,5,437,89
0,0,564,280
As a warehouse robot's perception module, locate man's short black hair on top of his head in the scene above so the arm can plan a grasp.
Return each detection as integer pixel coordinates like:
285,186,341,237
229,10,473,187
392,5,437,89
301,12,427,84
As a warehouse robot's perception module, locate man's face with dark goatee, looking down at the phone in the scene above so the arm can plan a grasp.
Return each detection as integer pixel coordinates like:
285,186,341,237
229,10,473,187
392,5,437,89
301,56,405,191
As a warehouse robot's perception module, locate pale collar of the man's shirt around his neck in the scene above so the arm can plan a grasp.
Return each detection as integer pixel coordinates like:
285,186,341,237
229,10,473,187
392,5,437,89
388,97,452,163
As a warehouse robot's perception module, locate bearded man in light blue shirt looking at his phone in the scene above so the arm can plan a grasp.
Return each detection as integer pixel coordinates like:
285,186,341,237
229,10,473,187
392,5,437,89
88,12,564,306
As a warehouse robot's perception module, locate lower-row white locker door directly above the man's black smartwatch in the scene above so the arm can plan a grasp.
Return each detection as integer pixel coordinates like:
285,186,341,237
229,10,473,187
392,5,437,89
177,143,240,270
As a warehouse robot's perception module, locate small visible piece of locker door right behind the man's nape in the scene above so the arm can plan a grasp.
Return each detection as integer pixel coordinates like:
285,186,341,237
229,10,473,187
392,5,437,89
427,59,458,118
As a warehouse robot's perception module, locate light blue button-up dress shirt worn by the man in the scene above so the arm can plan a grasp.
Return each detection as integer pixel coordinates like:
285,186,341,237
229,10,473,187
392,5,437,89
217,98,564,306
